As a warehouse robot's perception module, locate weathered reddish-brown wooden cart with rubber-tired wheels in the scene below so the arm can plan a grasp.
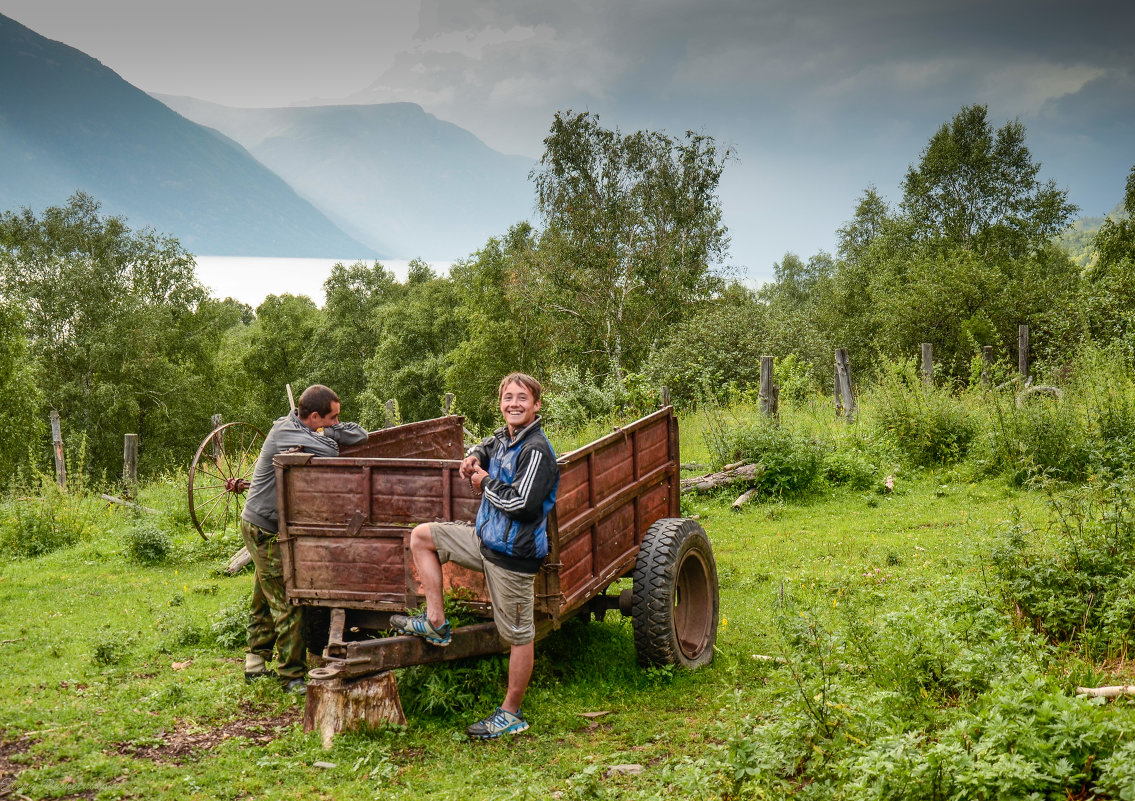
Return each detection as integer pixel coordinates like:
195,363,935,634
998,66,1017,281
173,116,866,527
275,406,717,694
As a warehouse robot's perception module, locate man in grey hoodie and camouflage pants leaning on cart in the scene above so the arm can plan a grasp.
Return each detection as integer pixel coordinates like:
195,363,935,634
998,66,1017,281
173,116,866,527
241,383,367,692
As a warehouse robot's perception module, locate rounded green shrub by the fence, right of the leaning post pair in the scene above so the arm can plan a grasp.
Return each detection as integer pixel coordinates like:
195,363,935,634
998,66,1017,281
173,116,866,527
869,360,978,467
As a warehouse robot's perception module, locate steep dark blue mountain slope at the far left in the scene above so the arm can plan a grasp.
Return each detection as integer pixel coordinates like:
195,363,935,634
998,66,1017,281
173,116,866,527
0,15,377,259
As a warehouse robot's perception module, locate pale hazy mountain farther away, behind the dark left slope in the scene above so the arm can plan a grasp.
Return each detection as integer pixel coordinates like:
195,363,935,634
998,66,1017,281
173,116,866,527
154,95,535,260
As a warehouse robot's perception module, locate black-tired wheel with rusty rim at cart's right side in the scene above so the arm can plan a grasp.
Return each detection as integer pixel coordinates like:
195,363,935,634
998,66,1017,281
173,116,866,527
631,517,718,669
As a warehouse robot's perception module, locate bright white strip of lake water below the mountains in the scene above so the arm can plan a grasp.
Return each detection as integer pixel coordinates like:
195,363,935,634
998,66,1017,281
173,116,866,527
195,256,452,309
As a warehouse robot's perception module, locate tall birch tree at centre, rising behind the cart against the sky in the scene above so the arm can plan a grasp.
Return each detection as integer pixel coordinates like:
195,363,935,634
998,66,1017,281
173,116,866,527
526,111,730,379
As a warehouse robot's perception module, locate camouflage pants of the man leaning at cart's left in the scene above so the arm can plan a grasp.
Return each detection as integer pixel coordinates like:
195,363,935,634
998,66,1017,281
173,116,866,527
241,520,308,680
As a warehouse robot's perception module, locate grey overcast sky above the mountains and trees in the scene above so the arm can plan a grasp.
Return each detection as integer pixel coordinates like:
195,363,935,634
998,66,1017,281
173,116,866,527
0,0,1135,280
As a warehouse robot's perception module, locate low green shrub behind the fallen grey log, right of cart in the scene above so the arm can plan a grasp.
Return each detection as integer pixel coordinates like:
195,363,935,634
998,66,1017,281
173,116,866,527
706,420,824,496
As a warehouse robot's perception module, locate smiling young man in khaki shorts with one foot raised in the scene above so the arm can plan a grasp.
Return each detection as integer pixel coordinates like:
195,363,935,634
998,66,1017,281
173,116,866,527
390,373,560,740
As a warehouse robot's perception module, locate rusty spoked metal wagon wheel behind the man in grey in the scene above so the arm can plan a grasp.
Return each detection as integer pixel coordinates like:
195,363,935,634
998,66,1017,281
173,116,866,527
190,423,264,539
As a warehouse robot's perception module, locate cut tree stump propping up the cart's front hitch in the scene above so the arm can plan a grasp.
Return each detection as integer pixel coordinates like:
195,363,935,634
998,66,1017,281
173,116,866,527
303,671,406,749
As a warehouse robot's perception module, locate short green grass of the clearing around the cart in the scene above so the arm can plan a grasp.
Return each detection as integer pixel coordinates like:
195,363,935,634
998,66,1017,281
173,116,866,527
0,465,1133,799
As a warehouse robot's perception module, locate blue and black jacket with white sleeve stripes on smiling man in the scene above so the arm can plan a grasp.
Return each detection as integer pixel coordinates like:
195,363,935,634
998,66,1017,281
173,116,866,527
469,418,560,573
